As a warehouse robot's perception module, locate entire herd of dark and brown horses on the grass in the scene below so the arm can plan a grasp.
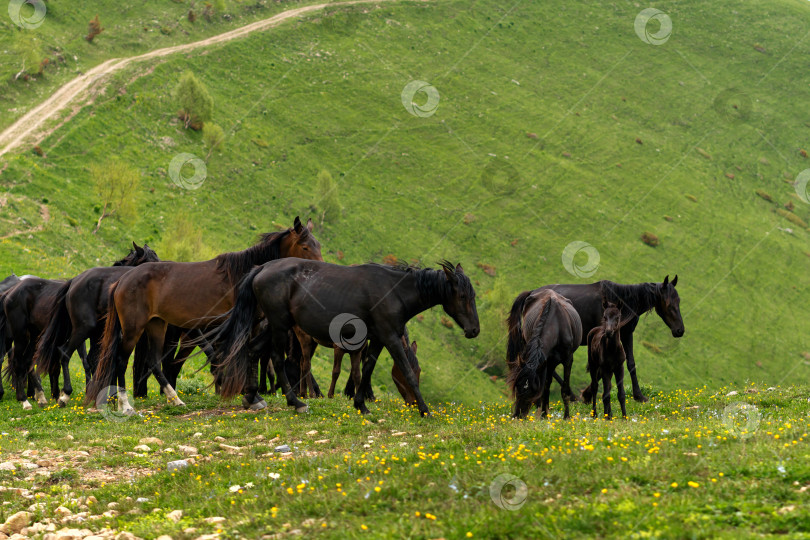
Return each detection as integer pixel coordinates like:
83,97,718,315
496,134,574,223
0,217,684,418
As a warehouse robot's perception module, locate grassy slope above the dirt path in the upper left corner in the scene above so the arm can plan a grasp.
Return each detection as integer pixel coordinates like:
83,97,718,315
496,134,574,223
0,0,332,128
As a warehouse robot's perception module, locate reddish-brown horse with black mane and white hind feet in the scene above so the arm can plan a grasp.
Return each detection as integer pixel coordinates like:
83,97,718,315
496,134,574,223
85,217,323,415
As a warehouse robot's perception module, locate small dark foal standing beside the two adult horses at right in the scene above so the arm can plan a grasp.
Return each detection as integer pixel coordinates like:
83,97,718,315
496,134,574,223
587,302,627,420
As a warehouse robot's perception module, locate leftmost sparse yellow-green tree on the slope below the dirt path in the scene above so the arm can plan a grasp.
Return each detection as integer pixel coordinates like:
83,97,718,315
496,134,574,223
90,161,141,234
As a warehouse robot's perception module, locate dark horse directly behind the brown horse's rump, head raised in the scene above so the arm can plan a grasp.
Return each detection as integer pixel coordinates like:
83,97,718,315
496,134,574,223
34,242,160,407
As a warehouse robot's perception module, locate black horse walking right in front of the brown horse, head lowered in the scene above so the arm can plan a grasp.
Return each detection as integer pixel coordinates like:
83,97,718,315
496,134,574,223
209,259,480,416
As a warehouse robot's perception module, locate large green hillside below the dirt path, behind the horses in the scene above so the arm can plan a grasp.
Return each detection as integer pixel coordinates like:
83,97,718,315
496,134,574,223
0,1,810,402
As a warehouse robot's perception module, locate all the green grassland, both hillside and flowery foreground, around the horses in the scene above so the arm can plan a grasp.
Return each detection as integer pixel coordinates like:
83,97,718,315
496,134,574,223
0,0,810,538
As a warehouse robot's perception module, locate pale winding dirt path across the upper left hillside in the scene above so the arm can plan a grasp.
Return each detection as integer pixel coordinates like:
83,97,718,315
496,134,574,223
0,0,400,156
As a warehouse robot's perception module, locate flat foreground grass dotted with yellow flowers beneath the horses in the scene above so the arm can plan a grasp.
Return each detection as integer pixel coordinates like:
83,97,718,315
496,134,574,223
0,364,810,539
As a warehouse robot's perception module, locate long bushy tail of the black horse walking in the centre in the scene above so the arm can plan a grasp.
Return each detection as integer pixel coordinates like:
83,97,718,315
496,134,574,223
210,266,263,399
